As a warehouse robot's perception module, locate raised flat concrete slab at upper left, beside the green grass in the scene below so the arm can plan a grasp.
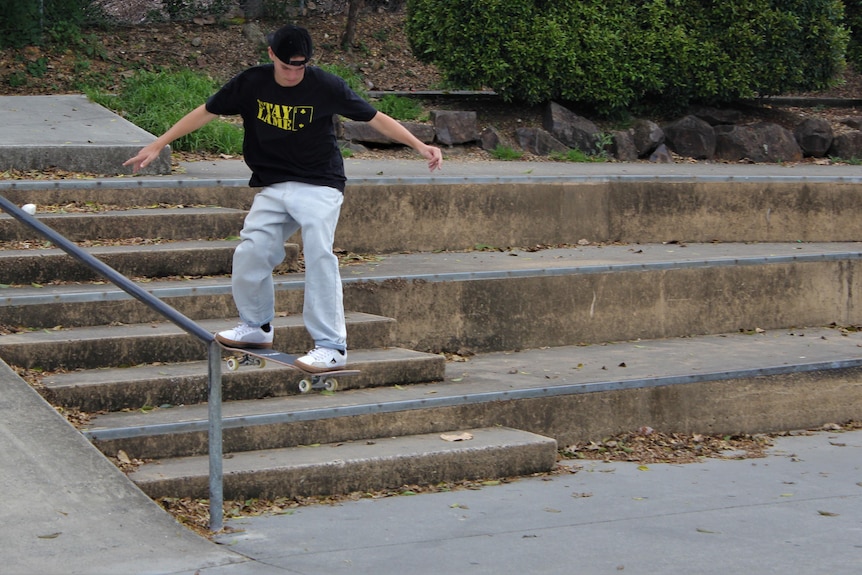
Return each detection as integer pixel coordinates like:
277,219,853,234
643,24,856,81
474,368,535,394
0,95,171,175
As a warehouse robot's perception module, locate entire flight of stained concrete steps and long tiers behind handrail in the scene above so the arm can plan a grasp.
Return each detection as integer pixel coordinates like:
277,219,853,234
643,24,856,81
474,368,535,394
0,177,862,499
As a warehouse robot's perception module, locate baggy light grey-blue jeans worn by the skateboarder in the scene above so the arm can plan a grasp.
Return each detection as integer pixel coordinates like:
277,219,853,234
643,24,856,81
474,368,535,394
231,182,347,351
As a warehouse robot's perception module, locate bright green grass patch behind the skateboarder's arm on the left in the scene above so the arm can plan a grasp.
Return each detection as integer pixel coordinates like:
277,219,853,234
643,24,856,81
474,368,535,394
87,70,242,154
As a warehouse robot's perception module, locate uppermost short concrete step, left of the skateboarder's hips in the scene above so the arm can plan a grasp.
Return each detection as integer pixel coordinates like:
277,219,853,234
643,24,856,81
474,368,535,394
0,207,246,242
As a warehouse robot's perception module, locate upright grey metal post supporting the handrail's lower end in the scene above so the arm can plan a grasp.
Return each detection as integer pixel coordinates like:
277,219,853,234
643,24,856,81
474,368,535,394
207,340,224,533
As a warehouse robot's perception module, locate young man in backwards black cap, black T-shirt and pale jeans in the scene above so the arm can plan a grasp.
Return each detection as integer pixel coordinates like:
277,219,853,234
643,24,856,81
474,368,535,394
123,25,443,372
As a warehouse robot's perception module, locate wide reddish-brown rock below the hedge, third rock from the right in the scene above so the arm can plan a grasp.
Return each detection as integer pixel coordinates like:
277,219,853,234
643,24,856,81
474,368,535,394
715,122,802,163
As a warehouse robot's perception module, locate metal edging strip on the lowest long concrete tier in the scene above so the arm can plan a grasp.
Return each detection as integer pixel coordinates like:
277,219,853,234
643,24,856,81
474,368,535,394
81,359,862,441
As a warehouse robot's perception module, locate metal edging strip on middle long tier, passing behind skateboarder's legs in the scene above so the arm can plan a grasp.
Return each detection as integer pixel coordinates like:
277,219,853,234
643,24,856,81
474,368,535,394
6,251,862,307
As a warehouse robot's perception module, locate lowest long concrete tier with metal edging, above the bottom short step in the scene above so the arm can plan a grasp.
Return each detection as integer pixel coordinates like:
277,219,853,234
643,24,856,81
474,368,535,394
83,327,862,459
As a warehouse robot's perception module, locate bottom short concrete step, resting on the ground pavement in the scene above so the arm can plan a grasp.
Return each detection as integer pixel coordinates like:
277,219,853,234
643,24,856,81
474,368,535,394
129,427,557,499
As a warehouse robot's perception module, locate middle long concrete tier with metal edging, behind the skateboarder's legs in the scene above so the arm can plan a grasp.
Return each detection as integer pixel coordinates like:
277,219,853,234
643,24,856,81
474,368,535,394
0,242,862,353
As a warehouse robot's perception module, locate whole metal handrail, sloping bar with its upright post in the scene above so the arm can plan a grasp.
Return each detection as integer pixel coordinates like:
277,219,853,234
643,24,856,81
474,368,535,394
0,195,224,532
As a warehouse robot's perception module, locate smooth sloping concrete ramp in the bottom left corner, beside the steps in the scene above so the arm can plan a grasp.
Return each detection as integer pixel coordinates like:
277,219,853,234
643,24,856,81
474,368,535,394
0,362,240,575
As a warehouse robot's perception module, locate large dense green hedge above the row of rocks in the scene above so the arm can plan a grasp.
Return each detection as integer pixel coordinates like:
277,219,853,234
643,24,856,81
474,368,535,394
407,0,847,114
